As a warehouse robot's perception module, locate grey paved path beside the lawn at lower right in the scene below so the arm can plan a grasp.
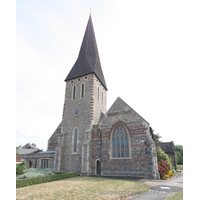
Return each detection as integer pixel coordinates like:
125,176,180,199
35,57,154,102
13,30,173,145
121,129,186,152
128,172,183,200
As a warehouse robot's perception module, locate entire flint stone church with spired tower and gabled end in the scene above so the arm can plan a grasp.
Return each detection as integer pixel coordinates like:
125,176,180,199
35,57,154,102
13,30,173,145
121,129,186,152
25,15,159,178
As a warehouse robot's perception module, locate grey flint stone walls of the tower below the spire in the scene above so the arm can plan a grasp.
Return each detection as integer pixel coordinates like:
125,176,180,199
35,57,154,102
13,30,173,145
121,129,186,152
55,74,107,174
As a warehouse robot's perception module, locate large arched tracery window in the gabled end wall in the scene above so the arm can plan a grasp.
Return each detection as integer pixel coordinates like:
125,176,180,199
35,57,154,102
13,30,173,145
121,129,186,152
112,125,129,158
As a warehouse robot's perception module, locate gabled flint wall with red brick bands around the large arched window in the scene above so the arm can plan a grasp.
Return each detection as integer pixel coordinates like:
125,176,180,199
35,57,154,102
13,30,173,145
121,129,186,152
91,98,159,178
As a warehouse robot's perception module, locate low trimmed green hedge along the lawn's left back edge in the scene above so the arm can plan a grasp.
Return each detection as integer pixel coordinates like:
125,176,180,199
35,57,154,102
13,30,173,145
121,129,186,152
16,172,77,188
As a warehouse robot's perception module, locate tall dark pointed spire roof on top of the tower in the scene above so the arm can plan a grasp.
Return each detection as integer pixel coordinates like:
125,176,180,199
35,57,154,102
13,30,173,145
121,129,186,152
65,15,107,90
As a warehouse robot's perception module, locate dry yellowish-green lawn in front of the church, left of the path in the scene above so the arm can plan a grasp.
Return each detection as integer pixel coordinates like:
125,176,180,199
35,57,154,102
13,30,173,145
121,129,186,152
16,176,150,200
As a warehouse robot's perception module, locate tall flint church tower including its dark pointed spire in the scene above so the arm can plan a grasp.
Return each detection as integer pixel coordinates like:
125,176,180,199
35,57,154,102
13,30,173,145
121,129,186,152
54,15,107,174
